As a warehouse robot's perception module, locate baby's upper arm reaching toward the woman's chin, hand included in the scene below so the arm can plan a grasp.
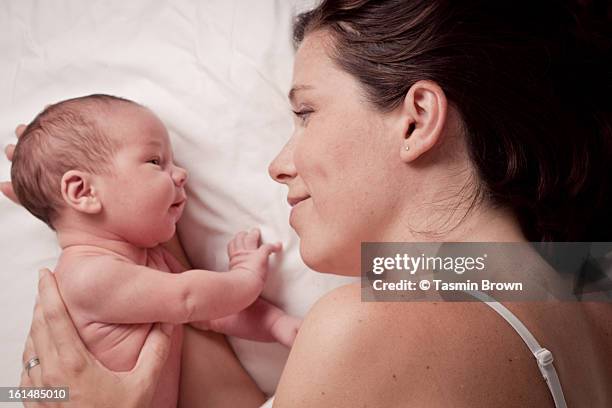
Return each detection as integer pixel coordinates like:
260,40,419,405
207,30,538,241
60,233,280,324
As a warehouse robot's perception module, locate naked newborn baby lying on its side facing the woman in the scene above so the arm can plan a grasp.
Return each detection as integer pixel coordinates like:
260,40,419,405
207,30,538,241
11,95,299,407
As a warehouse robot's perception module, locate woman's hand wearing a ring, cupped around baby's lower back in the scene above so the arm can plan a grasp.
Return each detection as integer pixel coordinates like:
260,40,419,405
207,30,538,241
20,269,173,408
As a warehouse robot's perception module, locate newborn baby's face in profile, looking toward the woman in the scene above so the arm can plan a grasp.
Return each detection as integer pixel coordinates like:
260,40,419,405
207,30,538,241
98,106,187,247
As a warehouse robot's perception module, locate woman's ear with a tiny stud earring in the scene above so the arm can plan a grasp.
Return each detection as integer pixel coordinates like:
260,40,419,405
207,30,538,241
400,81,447,163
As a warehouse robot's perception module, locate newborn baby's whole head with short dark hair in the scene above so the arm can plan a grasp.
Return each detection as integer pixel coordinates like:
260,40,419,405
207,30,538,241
11,95,187,247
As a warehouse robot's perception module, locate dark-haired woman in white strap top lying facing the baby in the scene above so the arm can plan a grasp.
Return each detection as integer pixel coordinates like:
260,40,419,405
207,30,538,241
8,0,612,407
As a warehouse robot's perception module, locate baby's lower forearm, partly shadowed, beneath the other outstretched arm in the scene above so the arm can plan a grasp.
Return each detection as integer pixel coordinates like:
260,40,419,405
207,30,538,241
191,297,302,347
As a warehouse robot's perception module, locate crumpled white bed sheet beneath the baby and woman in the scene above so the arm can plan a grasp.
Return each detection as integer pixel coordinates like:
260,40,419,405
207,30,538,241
0,0,349,393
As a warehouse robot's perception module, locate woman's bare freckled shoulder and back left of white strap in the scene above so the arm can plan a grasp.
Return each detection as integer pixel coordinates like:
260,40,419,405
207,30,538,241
275,284,572,408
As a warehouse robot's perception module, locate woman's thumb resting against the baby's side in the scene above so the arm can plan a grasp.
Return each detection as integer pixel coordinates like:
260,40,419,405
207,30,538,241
130,323,174,386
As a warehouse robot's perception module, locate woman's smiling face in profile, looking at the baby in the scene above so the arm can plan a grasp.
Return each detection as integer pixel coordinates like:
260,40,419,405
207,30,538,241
269,32,405,275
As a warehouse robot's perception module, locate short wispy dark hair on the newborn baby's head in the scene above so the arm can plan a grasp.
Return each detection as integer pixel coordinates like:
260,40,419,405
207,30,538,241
11,94,137,229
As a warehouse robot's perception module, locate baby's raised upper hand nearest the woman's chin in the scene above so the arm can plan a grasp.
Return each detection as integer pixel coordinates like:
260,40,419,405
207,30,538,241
227,228,282,281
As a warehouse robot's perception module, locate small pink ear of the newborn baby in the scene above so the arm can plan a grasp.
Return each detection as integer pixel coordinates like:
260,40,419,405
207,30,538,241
61,170,102,214
